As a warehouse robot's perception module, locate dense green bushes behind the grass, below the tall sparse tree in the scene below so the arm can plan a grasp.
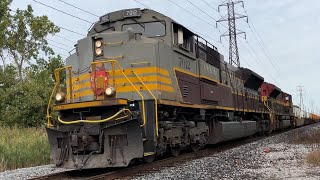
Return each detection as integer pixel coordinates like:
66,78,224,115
0,56,64,127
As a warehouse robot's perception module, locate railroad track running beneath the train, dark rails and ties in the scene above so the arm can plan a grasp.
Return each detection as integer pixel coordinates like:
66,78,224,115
32,129,304,180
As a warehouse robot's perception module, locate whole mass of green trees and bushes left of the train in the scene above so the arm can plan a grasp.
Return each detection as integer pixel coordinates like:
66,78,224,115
0,0,64,127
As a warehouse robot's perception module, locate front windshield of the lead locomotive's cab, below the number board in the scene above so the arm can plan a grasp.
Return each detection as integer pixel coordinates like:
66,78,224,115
122,21,166,37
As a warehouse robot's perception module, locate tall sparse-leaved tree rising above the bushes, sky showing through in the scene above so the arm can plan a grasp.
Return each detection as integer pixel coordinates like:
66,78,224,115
6,5,60,80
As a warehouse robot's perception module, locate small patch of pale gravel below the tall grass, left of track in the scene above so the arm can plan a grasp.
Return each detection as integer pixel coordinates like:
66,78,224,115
0,164,66,180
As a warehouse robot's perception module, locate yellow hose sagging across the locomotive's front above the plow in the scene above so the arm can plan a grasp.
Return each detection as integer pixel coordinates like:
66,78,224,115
58,109,132,124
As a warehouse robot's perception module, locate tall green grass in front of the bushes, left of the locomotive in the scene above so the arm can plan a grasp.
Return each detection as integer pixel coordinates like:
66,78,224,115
0,127,50,172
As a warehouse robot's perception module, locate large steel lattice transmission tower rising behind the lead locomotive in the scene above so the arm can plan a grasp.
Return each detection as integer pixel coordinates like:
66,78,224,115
217,0,248,67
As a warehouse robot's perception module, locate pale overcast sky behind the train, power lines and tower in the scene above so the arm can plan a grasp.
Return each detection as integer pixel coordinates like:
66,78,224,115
11,0,320,114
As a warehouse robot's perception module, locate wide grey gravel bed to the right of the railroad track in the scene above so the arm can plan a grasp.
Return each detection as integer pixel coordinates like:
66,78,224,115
134,123,320,180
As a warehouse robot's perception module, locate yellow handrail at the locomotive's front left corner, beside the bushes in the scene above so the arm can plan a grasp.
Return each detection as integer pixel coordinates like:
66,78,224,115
47,66,72,127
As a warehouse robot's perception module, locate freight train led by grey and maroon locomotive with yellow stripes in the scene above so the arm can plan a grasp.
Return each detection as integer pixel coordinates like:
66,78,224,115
46,8,314,169
